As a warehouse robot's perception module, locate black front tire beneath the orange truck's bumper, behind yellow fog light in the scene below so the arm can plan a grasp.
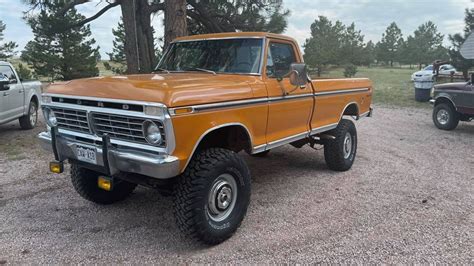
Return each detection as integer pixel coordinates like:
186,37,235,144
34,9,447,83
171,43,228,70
71,163,137,205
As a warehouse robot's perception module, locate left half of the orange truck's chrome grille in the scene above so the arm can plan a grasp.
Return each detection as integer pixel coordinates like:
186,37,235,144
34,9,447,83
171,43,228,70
51,107,90,133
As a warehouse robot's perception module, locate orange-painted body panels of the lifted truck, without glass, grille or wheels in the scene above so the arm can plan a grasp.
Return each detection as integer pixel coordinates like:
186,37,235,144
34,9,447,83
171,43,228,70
47,33,373,172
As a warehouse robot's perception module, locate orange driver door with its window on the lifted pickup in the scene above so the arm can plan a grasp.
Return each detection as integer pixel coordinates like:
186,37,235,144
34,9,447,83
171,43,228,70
264,40,313,145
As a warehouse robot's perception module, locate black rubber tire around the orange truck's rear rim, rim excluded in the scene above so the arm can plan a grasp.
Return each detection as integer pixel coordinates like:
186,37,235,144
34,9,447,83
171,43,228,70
324,119,357,172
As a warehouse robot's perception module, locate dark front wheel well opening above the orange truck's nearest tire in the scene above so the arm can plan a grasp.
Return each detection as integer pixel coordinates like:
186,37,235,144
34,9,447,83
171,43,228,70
196,125,252,153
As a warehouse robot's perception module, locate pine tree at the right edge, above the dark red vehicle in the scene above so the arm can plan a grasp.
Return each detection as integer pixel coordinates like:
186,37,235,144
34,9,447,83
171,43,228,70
449,8,474,79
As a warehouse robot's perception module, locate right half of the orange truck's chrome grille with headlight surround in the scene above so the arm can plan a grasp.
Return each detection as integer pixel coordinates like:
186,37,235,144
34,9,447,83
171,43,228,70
92,113,166,146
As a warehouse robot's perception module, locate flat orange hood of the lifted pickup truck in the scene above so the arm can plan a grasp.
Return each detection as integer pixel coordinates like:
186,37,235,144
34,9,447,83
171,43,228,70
46,72,260,107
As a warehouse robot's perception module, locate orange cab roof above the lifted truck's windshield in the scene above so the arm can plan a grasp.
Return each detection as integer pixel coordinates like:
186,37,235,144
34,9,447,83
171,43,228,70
173,32,296,43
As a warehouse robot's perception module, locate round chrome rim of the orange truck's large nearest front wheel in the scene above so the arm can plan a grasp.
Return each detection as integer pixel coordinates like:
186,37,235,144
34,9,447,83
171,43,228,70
207,174,237,222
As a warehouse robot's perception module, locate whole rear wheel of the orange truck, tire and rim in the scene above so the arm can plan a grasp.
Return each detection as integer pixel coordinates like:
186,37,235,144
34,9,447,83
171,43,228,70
324,119,357,172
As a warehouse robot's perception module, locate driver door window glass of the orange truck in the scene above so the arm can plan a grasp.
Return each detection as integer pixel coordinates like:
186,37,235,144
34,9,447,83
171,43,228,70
267,42,296,78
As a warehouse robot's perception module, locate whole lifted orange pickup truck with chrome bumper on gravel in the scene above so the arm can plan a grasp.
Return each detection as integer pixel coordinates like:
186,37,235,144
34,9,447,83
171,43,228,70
39,33,373,244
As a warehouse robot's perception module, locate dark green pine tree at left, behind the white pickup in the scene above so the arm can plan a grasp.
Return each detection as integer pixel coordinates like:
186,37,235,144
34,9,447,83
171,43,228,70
21,1,100,80
